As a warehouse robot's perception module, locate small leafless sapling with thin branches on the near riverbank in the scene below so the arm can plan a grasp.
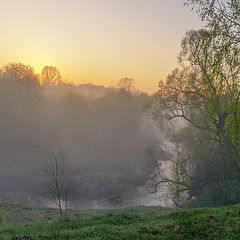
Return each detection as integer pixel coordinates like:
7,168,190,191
39,148,71,217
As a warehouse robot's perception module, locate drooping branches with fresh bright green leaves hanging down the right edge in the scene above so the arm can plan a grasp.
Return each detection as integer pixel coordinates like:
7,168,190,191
185,0,240,154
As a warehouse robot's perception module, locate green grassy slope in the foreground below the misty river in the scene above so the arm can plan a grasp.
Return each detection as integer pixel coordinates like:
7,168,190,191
0,202,240,240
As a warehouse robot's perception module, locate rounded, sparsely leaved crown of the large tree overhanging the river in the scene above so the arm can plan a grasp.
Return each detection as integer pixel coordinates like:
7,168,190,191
153,26,240,170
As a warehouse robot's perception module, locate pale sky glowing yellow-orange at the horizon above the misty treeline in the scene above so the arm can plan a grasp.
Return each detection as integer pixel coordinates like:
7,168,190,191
0,0,203,93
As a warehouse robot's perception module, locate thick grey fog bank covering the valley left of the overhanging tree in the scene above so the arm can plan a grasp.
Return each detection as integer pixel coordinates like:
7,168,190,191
0,66,171,209
